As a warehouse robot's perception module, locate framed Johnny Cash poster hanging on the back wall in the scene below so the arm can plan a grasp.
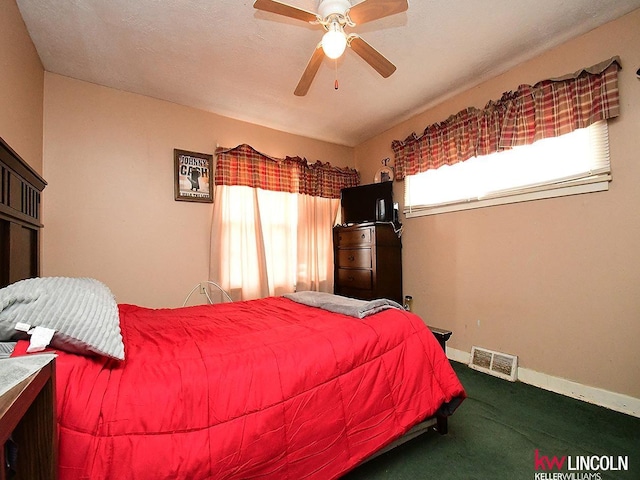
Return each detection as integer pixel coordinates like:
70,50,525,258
173,148,213,203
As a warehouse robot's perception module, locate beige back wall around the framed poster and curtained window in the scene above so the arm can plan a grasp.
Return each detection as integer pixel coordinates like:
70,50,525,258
42,73,353,307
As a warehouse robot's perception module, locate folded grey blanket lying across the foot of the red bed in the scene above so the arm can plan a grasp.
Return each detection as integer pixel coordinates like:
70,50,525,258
283,291,403,318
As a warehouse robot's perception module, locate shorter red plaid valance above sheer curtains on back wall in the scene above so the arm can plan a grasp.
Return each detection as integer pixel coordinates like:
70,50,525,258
215,144,360,198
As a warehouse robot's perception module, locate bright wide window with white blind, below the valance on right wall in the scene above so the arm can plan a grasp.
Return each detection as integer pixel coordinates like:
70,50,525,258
404,120,611,217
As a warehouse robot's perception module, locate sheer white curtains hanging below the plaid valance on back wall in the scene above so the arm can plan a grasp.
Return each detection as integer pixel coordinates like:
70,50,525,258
210,185,340,300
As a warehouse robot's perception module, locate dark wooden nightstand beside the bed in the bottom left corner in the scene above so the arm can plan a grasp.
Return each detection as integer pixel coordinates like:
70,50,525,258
0,359,58,480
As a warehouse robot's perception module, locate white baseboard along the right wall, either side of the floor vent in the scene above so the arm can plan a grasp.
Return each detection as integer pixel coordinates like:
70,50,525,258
447,347,640,417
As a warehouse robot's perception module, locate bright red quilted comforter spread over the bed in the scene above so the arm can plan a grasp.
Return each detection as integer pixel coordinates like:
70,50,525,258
16,297,465,480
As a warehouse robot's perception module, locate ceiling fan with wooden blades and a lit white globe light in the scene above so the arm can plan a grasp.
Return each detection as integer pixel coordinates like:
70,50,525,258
253,0,409,96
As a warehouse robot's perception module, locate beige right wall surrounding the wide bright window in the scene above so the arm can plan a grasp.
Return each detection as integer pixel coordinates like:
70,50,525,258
356,10,640,398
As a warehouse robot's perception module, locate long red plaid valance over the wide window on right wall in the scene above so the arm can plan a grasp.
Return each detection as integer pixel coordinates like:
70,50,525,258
391,57,620,180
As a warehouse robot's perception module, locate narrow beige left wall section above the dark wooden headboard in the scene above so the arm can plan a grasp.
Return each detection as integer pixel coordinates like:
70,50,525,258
0,0,44,173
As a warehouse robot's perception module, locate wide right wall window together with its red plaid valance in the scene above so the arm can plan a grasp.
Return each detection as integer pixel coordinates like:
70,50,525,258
391,57,620,217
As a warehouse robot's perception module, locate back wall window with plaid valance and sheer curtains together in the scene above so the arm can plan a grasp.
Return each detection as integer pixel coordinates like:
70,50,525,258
209,144,359,300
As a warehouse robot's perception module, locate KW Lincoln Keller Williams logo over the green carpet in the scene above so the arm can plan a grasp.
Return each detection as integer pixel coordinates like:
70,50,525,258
533,449,629,480
